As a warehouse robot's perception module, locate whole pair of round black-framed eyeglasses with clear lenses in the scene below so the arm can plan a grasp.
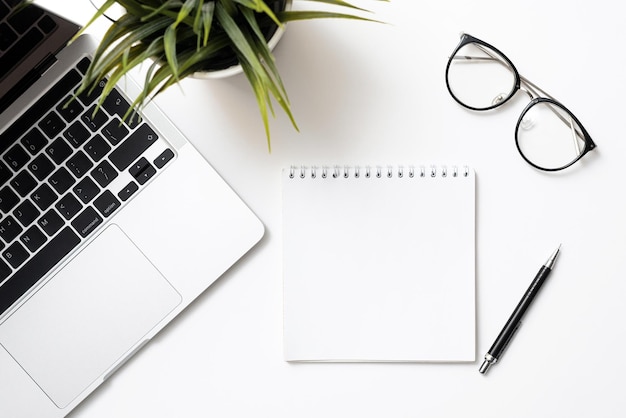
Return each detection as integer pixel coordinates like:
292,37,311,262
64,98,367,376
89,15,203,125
446,34,596,171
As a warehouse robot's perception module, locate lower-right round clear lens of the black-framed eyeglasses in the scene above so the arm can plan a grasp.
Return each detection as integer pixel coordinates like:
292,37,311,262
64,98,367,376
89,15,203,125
515,101,585,170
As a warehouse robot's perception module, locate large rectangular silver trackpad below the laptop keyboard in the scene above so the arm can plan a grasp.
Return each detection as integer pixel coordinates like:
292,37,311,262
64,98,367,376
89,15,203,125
0,225,181,408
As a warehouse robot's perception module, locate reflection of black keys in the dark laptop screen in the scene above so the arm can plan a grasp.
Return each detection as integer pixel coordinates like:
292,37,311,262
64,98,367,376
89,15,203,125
0,0,57,79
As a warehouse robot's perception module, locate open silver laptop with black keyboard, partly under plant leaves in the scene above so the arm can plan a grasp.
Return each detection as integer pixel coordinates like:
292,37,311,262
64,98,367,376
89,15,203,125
0,0,264,418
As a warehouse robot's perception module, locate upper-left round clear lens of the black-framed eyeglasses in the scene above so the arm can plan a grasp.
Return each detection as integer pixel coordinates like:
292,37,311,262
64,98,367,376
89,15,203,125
447,42,516,110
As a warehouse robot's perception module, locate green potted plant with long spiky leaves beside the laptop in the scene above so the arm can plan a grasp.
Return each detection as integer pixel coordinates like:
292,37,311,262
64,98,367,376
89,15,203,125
77,0,386,148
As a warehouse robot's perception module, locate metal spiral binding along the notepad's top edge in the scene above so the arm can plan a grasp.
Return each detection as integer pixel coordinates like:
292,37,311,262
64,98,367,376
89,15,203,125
288,165,470,179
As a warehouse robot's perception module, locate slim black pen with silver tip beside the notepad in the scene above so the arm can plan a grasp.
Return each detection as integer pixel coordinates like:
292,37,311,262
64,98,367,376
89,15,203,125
478,245,561,374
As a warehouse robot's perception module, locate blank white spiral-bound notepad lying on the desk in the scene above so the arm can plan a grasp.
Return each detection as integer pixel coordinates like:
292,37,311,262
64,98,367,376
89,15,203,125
282,165,476,362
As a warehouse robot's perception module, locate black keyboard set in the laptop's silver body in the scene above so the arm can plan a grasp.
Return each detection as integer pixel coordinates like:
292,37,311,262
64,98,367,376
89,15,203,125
0,57,174,314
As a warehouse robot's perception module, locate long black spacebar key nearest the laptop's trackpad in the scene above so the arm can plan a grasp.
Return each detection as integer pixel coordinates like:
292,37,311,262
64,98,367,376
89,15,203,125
0,227,80,315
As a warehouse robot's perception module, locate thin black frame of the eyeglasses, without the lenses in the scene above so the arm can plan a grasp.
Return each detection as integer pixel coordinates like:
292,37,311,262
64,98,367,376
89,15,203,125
446,33,596,171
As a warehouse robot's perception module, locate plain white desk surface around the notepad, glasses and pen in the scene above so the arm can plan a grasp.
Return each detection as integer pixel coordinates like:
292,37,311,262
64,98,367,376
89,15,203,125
38,0,626,418
